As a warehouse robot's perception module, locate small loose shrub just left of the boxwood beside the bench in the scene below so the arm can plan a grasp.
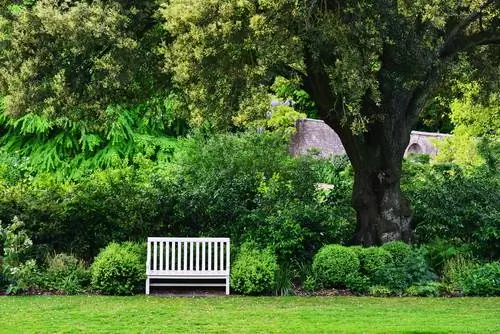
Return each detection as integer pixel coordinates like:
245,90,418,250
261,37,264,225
41,253,90,295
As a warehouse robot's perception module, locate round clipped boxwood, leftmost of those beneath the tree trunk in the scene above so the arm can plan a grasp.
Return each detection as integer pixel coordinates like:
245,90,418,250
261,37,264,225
313,245,360,288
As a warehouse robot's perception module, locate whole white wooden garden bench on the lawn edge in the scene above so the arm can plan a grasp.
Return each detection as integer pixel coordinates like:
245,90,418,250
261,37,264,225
146,237,230,295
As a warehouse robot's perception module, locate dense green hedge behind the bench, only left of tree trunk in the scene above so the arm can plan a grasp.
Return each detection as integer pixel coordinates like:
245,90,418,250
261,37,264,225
0,133,355,262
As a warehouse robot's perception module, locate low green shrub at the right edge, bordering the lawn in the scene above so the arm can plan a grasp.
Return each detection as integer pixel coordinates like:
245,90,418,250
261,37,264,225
462,262,500,296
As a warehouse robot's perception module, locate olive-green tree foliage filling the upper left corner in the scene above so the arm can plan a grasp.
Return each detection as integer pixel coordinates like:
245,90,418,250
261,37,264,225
0,0,169,122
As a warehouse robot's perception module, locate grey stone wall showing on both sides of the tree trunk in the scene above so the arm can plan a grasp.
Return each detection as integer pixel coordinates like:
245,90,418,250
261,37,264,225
290,118,450,157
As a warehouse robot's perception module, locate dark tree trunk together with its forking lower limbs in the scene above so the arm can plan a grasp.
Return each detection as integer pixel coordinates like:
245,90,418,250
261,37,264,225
304,47,418,245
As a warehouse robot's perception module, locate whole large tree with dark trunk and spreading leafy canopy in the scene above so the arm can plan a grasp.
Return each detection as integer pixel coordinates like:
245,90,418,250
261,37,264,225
162,0,500,245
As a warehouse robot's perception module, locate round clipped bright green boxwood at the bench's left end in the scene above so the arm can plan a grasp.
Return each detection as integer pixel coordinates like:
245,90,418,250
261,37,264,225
90,242,146,295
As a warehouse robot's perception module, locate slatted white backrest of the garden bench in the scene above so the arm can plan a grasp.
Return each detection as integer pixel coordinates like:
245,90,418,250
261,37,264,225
146,237,230,275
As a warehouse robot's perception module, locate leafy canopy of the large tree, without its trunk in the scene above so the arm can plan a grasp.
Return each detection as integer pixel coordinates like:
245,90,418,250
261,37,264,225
162,0,499,133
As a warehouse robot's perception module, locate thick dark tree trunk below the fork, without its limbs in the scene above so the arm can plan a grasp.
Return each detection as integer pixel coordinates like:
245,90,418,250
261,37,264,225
329,103,412,246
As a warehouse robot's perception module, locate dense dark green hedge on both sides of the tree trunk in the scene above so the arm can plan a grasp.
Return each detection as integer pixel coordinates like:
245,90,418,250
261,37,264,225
0,133,500,274
